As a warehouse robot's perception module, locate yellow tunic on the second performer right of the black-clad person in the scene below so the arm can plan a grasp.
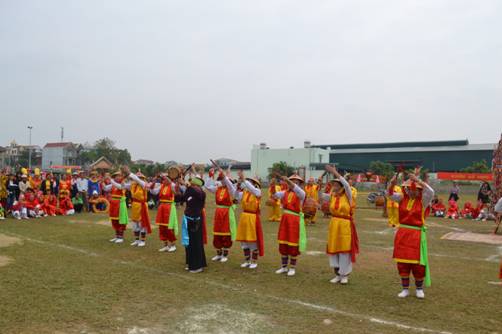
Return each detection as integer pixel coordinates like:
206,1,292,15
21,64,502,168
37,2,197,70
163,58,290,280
236,190,260,242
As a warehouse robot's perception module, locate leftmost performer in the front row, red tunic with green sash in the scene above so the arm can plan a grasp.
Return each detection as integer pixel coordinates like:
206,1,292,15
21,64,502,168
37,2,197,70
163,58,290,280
104,170,129,244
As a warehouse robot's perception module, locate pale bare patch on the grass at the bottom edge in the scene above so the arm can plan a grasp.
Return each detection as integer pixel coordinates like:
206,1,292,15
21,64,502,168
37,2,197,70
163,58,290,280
176,304,271,334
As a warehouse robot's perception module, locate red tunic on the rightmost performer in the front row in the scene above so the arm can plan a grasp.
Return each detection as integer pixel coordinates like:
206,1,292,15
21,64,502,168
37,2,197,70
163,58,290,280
393,193,424,263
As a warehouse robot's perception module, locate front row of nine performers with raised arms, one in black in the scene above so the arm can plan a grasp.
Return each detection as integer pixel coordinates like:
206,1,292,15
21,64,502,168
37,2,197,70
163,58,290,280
106,165,434,298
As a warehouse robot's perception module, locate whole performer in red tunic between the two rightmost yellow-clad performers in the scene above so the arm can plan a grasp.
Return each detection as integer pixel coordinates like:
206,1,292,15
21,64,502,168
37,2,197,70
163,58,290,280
272,174,307,276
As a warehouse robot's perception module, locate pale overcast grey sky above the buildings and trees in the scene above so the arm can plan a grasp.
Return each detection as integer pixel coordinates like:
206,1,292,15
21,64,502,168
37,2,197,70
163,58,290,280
0,0,502,162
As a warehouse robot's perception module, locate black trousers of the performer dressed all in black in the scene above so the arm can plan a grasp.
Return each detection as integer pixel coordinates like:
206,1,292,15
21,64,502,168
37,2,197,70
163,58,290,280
185,217,207,270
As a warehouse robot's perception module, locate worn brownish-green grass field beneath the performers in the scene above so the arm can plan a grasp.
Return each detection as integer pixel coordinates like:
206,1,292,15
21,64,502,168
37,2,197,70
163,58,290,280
0,194,502,333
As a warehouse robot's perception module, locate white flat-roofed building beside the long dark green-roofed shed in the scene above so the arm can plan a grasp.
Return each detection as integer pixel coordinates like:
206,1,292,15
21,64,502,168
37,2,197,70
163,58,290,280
251,141,330,180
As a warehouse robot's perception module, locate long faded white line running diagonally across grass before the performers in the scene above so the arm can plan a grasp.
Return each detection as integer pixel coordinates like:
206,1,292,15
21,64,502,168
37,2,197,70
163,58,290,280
9,233,451,334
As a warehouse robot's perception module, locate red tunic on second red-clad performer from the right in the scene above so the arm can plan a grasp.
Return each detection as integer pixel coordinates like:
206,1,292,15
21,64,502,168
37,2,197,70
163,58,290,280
277,190,302,246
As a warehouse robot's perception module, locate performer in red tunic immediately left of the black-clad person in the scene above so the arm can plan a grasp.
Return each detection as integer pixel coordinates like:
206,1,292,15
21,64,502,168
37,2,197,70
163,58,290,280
150,173,178,253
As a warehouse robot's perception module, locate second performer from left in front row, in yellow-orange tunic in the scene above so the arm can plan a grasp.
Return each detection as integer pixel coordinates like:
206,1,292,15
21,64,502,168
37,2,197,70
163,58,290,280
122,167,152,247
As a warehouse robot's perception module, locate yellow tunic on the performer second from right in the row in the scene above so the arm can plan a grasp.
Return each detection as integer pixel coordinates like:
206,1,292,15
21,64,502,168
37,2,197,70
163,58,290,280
327,193,352,254
